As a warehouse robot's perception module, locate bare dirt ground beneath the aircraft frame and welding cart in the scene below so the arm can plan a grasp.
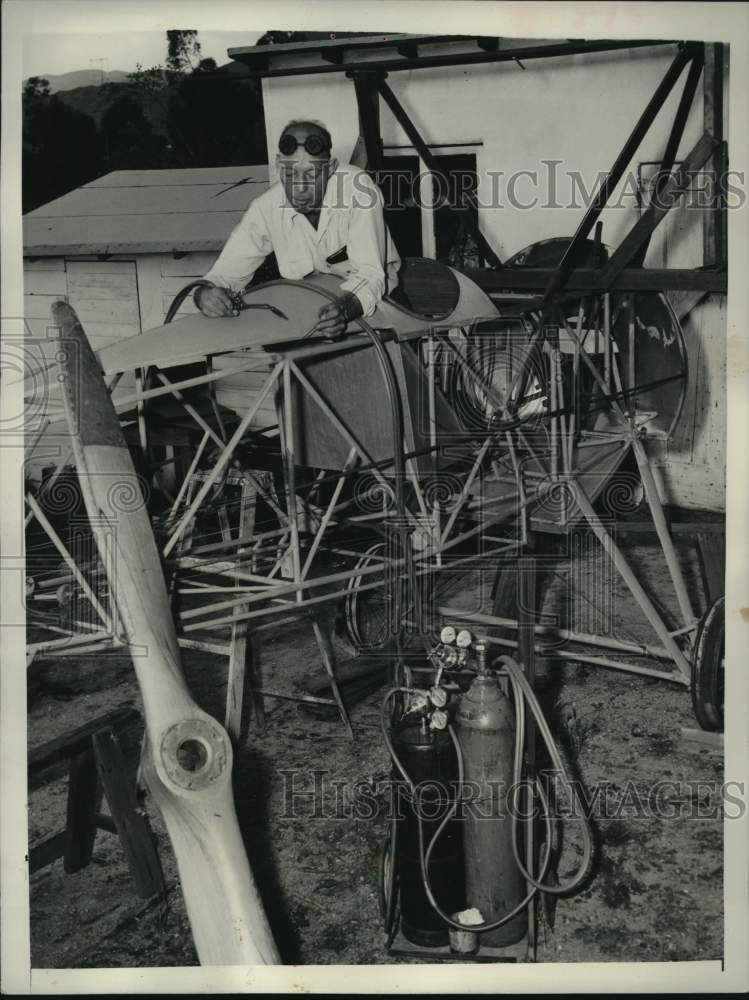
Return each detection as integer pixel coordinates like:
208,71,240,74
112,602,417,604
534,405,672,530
29,520,723,968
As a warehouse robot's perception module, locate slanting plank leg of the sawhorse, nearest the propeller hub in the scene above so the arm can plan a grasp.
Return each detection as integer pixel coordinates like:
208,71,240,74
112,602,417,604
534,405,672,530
94,729,164,899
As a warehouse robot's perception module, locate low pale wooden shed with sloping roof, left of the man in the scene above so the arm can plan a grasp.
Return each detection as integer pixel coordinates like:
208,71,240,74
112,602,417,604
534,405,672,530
23,166,275,479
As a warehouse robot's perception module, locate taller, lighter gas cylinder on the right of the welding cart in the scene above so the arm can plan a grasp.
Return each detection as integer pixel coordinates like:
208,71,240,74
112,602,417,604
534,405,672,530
455,670,528,948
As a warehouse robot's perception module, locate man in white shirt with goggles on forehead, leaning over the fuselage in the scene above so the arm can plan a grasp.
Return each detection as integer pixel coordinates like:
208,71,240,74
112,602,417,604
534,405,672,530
195,120,400,337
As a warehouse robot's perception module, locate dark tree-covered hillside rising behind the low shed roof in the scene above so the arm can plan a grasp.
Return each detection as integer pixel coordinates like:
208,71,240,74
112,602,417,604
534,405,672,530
23,71,267,212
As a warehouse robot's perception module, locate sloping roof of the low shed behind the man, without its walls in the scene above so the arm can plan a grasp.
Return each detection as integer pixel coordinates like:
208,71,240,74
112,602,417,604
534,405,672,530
23,166,269,257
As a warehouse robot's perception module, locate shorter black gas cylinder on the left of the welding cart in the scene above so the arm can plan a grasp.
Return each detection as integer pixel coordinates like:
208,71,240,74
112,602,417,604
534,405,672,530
393,719,464,948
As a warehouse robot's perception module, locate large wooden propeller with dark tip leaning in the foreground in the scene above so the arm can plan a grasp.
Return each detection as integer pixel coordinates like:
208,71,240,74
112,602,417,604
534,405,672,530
52,302,280,965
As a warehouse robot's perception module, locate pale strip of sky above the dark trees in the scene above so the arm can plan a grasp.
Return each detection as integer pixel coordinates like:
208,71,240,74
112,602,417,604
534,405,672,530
23,30,261,79
